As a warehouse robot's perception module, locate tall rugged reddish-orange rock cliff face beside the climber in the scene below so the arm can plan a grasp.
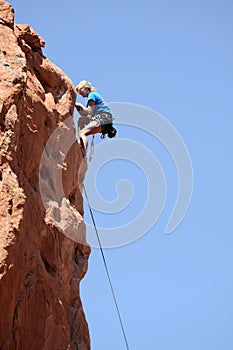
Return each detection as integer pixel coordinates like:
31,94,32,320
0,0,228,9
0,0,90,350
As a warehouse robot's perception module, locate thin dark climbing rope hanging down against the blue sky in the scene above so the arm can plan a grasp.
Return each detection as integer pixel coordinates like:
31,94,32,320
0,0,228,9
83,184,129,350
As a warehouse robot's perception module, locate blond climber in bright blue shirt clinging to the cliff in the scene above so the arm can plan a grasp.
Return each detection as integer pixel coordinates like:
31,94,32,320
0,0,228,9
75,80,117,152
